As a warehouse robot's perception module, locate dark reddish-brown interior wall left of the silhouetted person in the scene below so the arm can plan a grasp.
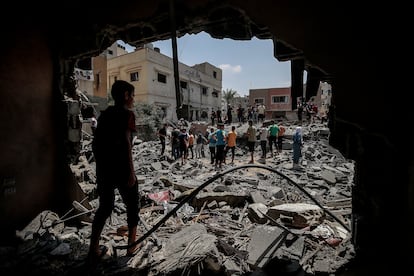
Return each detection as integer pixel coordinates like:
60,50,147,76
0,28,59,240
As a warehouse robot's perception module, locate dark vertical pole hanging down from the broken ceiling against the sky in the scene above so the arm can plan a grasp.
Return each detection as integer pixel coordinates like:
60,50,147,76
170,0,181,120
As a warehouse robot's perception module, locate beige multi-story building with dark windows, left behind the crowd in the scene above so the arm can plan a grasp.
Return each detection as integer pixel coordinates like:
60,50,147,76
81,43,222,121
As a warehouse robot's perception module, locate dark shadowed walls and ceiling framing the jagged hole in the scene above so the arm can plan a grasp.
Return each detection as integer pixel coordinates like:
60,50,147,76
0,0,414,275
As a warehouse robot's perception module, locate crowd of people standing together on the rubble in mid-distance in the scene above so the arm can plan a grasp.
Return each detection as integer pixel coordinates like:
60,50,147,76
158,120,302,168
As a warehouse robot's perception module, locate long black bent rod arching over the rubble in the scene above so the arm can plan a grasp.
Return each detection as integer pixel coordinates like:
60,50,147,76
113,164,351,250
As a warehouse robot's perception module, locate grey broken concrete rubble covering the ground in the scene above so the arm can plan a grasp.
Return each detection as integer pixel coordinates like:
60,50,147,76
0,119,354,275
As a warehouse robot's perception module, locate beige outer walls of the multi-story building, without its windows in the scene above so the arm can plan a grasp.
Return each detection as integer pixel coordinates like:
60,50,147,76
107,48,222,120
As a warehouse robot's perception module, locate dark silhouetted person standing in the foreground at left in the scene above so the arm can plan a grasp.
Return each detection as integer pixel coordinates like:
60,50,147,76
87,80,140,268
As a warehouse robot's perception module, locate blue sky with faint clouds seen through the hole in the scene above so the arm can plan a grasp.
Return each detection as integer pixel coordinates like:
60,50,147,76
121,32,291,95
